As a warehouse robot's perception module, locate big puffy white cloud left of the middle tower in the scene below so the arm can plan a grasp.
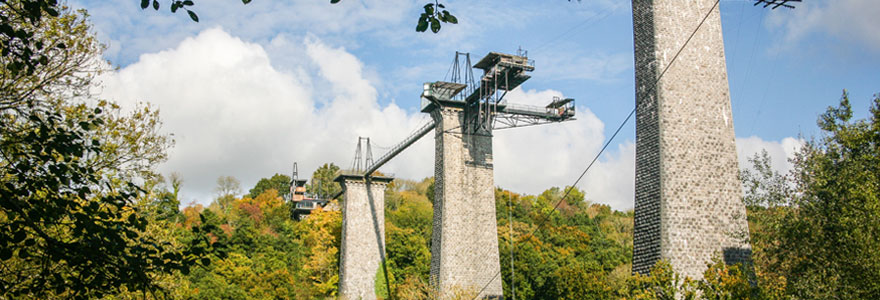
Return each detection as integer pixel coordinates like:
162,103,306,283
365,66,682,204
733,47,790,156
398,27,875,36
101,29,432,203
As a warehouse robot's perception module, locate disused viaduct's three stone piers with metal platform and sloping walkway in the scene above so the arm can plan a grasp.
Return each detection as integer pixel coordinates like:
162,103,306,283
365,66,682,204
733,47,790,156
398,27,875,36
337,0,751,299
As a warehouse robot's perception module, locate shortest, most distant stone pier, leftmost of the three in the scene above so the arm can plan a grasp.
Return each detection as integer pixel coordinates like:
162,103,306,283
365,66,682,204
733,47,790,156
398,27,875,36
335,175,393,300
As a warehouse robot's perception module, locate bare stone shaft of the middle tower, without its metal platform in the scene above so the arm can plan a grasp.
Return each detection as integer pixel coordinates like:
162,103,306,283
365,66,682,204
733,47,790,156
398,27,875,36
431,108,503,299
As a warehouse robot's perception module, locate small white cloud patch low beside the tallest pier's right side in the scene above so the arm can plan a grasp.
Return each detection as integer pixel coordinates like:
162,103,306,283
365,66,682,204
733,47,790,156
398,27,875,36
736,136,804,174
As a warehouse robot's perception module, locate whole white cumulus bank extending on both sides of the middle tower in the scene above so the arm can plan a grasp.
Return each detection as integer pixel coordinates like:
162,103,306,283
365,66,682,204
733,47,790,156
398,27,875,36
96,28,634,209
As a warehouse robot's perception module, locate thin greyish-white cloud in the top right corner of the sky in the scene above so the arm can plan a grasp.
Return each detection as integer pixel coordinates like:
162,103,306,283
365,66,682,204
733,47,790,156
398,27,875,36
767,0,880,51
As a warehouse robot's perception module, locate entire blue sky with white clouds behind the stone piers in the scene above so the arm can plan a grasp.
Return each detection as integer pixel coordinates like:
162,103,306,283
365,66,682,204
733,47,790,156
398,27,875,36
70,0,880,209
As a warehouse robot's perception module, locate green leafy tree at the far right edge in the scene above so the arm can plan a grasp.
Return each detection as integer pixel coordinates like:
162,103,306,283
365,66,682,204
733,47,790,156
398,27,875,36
771,91,880,299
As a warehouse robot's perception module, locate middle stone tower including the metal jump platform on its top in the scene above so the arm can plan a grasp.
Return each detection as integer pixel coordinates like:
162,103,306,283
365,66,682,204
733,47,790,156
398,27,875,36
414,52,575,299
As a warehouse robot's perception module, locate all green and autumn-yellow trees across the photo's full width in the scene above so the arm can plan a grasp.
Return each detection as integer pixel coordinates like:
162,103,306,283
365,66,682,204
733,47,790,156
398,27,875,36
0,0,880,299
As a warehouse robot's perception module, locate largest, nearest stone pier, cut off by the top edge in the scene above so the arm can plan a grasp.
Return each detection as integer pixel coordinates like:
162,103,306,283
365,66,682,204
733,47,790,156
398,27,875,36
633,0,751,279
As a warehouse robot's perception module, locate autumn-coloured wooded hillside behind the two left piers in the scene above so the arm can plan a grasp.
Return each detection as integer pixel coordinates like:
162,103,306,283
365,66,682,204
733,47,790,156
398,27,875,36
113,168,632,299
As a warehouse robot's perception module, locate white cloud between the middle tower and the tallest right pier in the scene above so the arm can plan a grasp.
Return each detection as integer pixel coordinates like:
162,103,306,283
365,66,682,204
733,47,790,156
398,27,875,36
494,89,635,210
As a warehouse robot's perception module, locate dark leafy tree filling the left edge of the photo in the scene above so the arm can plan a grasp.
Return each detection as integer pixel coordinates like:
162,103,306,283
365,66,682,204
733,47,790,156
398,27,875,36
0,0,206,299
